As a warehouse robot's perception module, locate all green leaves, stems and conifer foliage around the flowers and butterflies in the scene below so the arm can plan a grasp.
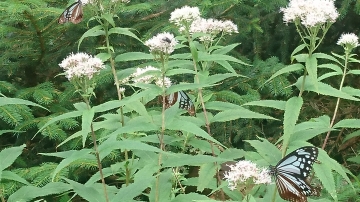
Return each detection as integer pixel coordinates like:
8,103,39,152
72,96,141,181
0,0,360,202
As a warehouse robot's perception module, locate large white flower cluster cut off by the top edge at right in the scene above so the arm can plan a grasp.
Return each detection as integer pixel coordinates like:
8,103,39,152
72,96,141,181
280,0,339,28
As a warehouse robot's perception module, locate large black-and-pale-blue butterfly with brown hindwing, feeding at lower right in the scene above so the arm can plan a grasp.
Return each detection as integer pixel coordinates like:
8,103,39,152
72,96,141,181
270,146,319,202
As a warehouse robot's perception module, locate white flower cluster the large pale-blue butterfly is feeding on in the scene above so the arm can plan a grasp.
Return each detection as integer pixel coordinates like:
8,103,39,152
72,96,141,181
224,161,271,190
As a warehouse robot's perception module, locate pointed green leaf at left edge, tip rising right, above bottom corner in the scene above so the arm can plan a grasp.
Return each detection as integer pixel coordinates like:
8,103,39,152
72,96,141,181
0,144,26,171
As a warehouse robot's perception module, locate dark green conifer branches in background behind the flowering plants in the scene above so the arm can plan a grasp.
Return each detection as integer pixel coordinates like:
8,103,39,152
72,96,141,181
0,0,360,201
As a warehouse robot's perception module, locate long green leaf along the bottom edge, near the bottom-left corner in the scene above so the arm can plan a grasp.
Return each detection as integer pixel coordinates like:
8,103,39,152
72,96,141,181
8,182,71,202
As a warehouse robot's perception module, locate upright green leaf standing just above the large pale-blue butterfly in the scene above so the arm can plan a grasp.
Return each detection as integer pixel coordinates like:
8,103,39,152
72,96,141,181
282,97,303,150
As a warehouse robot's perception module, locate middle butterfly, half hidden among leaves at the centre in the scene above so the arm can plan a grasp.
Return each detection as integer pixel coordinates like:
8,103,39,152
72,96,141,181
165,90,195,116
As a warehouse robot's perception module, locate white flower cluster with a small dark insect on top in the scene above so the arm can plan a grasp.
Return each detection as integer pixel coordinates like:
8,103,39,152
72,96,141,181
145,32,178,54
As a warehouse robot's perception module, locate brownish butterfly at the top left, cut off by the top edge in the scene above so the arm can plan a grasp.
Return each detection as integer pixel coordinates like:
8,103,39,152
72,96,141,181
58,0,83,24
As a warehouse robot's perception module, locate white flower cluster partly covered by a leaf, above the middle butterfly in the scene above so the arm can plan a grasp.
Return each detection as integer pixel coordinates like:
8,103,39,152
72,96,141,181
121,66,171,88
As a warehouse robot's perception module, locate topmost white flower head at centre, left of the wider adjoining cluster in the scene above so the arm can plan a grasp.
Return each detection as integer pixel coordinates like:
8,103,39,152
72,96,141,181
170,6,200,31
